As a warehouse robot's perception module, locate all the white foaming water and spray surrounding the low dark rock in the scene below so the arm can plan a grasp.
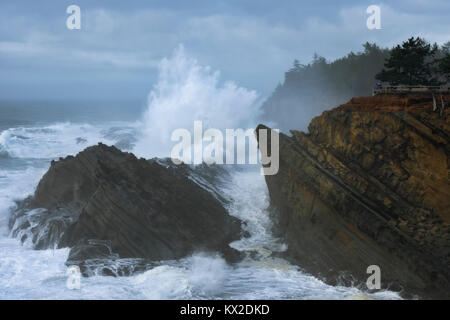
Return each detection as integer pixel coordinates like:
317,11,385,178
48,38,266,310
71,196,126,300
0,48,398,299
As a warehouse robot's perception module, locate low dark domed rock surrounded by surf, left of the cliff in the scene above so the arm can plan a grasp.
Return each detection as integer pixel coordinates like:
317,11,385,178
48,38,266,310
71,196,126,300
10,144,241,268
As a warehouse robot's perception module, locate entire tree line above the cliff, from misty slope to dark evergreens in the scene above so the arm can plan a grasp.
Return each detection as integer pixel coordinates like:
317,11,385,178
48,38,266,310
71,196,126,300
261,38,450,131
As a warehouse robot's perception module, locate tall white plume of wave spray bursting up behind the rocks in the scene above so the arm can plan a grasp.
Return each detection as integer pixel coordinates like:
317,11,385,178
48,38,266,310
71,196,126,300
134,46,259,157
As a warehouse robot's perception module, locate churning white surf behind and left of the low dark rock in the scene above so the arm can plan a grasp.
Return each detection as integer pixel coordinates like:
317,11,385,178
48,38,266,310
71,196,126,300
0,122,135,234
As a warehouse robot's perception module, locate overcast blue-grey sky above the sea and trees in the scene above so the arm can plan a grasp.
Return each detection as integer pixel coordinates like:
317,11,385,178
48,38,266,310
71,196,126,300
0,0,450,99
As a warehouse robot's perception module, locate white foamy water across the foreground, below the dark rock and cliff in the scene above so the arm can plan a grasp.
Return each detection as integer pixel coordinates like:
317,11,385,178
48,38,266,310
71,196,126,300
0,238,399,299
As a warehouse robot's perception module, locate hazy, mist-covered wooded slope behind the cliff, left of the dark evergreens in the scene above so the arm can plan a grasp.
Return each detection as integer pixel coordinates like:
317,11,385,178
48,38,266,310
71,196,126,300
262,43,389,130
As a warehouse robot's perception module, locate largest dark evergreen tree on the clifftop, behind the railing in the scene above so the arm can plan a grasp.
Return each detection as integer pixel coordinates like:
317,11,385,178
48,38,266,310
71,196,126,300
376,37,438,85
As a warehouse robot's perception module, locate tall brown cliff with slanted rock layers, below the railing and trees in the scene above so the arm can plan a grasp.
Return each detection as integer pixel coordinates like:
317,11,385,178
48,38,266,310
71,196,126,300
260,97,450,298
